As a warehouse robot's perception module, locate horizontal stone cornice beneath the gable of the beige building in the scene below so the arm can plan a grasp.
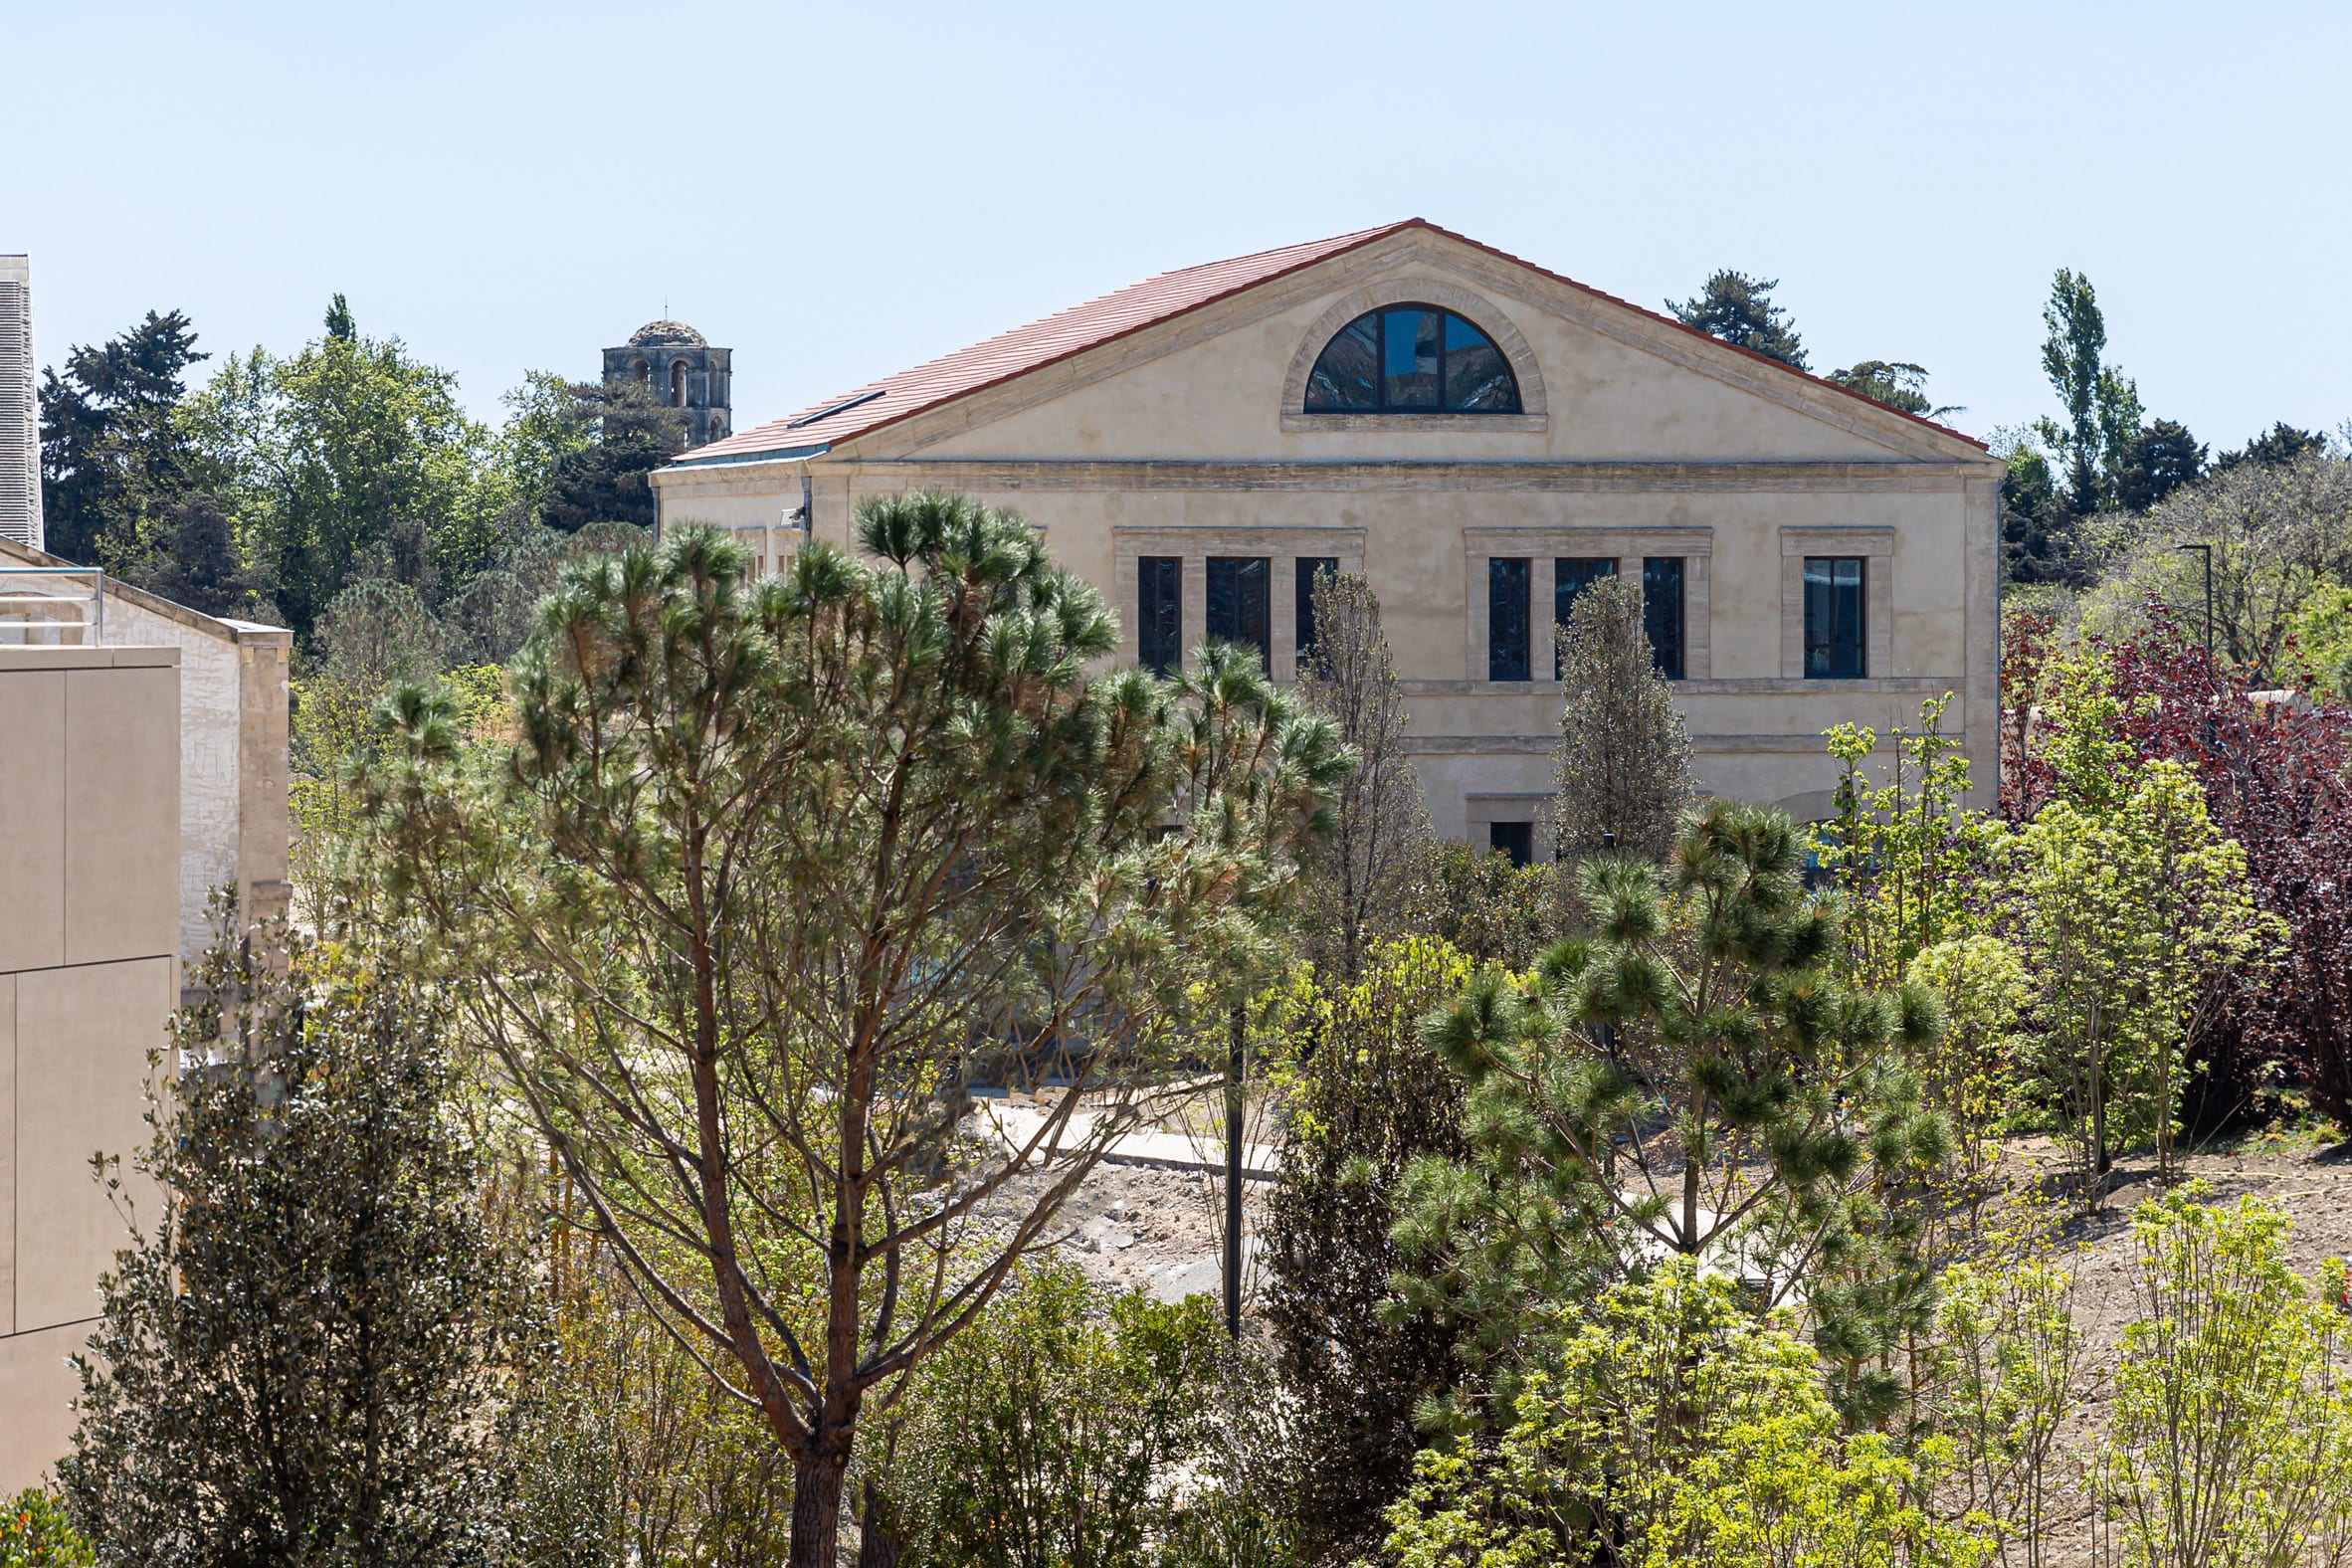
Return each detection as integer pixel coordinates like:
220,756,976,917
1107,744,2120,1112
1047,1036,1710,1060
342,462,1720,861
837,459,1983,493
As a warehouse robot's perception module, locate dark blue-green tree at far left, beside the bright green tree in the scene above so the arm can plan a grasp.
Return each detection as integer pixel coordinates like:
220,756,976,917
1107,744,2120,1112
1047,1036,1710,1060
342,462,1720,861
40,310,207,576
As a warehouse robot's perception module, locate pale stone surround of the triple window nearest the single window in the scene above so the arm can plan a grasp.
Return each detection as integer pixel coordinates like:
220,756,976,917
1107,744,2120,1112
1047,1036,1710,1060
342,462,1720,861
1463,524,1721,691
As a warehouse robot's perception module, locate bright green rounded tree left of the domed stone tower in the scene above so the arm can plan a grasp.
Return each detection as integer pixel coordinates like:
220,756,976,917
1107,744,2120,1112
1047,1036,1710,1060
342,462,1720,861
188,294,503,640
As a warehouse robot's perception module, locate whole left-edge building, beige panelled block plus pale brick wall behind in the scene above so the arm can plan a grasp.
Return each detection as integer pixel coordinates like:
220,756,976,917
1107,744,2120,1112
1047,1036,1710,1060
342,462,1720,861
0,556,292,1495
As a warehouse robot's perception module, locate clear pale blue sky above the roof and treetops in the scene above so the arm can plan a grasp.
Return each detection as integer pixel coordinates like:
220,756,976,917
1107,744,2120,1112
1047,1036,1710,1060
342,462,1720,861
0,0,2352,449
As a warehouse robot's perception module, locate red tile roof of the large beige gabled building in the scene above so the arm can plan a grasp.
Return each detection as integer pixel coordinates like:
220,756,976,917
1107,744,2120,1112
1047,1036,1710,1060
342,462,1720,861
680,219,1985,466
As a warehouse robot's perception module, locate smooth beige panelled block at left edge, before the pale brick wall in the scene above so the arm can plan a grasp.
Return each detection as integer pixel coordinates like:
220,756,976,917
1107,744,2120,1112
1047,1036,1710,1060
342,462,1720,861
0,644,181,1495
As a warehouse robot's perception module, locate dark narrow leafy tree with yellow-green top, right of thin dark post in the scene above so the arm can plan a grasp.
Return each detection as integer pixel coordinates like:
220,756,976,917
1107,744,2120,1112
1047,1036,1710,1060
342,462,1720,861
1261,938,1470,1561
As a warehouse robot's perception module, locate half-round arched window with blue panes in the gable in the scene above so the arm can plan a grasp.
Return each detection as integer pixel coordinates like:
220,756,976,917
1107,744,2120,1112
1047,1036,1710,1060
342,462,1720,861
1305,305,1519,414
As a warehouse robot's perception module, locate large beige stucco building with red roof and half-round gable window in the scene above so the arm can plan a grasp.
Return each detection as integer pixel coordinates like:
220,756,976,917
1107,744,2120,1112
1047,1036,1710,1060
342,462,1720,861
654,219,2002,854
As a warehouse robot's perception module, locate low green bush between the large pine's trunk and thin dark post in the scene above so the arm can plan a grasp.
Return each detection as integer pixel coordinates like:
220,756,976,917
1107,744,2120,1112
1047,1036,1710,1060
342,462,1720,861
886,1263,1223,1568
